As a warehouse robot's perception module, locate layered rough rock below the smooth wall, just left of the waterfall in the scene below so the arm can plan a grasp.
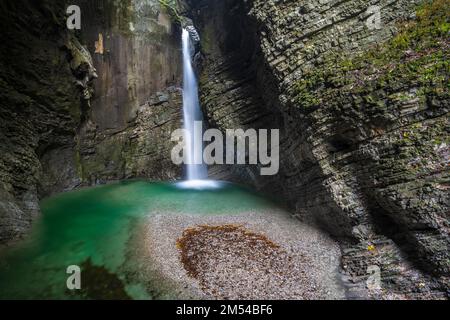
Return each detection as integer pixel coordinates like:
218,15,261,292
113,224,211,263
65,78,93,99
76,87,182,185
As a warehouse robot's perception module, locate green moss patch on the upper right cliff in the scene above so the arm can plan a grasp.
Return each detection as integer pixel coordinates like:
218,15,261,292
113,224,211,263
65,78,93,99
295,0,450,112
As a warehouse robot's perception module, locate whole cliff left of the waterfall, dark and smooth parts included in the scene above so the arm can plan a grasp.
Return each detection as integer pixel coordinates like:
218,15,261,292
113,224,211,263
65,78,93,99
0,0,182,242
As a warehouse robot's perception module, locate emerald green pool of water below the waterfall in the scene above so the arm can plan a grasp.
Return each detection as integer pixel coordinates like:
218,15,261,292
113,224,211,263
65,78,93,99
0,181,272,299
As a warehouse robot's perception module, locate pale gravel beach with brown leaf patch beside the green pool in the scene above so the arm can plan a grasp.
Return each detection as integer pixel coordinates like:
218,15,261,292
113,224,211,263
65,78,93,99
134,209,345,300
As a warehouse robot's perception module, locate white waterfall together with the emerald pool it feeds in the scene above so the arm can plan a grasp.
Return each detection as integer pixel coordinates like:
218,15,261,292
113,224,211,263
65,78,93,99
0,30,282,300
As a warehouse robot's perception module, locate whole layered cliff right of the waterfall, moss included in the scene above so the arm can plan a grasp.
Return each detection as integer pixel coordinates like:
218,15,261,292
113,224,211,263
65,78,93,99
191,0,450,297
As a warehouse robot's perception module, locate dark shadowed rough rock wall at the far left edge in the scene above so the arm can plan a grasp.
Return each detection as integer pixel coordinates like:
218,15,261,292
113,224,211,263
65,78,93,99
0,1,85,242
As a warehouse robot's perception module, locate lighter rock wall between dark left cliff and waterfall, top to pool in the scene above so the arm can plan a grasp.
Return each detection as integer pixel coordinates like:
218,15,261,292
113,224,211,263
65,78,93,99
70,0,182,188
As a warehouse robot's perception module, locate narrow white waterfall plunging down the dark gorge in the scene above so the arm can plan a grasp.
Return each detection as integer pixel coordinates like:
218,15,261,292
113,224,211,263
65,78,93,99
182,29,208,181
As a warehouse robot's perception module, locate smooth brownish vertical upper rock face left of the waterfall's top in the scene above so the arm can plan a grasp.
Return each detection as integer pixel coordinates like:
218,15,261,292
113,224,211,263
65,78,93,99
78,0,182,130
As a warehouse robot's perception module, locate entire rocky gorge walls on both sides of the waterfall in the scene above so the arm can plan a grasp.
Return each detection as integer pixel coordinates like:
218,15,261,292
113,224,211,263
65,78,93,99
0,0,450,298
